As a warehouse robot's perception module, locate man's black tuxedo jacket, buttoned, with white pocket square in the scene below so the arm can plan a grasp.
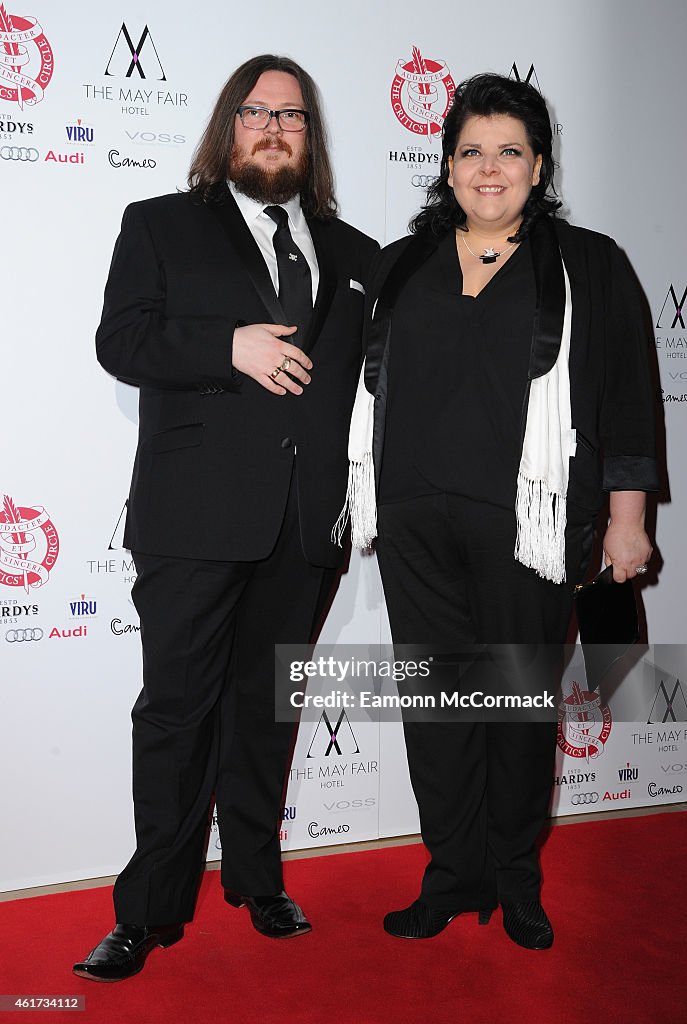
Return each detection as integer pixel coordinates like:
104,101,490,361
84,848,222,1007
96,189,379,566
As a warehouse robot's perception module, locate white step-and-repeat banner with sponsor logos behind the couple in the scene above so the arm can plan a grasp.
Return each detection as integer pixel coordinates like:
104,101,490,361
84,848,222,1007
0,0,687,890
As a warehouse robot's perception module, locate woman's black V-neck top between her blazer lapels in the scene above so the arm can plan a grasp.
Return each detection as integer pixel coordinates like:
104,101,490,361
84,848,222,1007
379,231,536,509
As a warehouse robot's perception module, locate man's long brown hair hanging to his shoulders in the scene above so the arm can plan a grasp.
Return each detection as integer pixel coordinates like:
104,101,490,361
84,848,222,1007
187,53,338,217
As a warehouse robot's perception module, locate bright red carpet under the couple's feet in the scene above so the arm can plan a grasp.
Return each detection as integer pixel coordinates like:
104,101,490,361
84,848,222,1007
0,813,687,1024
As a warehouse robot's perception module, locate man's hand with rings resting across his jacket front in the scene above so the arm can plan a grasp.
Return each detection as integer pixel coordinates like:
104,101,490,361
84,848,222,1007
231,324,312,394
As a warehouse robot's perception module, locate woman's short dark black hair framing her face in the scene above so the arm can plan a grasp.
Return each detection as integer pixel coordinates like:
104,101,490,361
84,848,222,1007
411,74,562,242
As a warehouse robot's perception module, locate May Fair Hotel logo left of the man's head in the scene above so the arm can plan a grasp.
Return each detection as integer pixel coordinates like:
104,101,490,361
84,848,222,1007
83,22,188,117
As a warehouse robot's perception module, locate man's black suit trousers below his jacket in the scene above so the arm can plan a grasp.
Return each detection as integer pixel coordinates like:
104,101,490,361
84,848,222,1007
114,481,335,925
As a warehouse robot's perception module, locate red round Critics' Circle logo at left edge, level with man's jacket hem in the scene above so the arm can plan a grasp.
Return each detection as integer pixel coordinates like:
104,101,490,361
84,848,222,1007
0,495,59,593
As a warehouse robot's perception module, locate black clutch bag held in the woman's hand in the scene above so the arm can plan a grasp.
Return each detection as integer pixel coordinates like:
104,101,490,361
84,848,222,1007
574,565,639,690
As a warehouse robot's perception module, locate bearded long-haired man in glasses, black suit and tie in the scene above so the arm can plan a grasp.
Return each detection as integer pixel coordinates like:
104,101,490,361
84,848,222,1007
74,54,378,981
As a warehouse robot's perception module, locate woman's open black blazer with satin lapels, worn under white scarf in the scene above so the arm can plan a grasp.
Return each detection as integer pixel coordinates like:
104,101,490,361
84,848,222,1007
366,217,658,521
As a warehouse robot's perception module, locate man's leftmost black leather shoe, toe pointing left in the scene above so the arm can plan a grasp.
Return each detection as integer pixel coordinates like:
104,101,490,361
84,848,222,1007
72,925,183,981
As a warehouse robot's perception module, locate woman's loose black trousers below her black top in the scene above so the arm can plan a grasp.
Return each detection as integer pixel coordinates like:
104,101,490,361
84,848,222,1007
377,494,593,910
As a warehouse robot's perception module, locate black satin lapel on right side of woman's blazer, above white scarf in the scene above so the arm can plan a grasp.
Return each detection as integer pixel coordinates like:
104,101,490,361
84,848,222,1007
529,216,565,380
